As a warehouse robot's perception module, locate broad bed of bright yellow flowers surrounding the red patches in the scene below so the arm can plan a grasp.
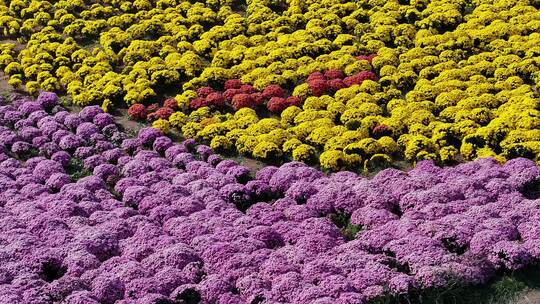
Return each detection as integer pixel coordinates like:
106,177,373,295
0,0,540,171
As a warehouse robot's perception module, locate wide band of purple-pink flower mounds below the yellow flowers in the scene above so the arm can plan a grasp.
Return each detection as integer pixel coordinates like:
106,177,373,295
0,93,540,304
